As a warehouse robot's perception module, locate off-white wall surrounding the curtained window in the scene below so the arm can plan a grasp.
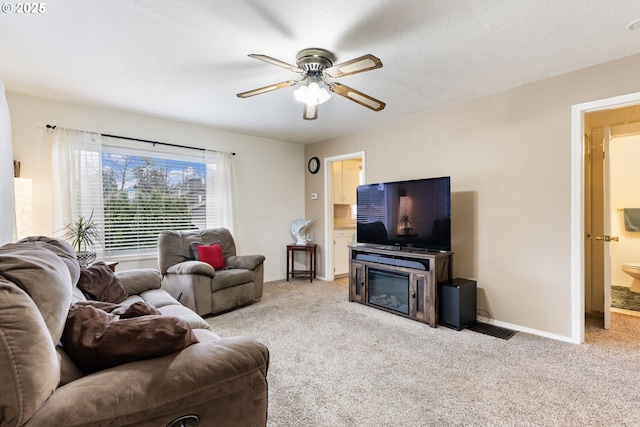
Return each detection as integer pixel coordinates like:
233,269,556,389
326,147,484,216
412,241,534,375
7,93,305,281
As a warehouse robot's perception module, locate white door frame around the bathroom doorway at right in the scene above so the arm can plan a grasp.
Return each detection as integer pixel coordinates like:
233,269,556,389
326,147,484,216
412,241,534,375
571,92,640,343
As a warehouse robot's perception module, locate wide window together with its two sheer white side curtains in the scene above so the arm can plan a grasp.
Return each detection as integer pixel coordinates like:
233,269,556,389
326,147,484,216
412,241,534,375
51,128,234,258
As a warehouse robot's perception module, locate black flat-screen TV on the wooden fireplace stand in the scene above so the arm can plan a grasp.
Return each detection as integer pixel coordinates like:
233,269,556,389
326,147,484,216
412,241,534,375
356,176,451,251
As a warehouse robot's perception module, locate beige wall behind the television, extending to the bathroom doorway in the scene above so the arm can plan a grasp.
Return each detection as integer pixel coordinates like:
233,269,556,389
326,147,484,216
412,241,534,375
305,51,640,339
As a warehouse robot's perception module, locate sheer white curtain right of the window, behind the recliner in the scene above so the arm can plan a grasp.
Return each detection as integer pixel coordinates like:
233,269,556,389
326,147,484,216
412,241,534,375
205,150,235,234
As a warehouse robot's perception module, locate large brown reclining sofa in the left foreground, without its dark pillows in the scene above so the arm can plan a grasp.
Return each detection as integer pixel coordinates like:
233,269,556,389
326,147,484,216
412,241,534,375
0,237,269,427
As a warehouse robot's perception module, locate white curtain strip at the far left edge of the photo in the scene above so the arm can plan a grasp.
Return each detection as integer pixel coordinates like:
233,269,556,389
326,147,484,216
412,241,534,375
0,81,16,245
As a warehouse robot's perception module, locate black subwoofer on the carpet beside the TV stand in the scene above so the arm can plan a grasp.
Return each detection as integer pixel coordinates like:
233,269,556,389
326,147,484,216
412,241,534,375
438,279,477,331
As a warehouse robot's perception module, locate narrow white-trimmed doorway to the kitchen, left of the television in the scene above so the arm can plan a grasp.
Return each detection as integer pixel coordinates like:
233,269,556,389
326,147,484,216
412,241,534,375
324,151,365,280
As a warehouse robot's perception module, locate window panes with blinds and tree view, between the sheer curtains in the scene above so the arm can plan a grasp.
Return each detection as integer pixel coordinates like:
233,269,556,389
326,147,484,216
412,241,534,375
102,150,207,256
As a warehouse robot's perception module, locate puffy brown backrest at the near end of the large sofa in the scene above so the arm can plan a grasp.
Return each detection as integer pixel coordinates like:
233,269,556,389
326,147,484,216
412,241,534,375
0,243,71,426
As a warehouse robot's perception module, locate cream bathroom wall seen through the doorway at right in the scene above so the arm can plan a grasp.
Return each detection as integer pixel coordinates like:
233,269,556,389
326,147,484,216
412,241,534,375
609,135,640,286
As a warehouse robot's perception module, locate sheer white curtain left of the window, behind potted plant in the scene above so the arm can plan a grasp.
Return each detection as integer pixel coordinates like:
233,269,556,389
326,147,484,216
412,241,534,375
51,128,104,259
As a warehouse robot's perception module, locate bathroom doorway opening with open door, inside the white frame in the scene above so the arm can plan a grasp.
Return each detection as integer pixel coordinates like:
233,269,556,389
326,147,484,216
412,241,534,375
585,115,640,329
